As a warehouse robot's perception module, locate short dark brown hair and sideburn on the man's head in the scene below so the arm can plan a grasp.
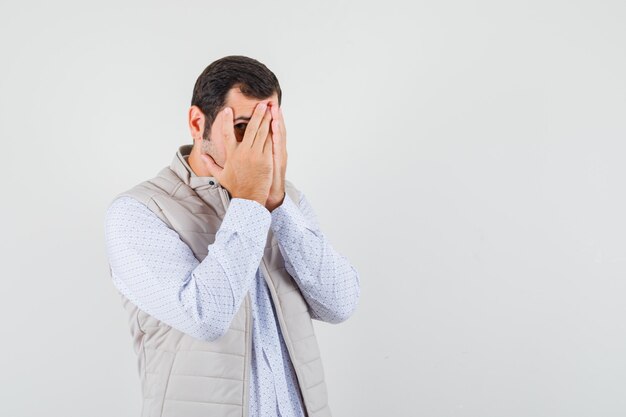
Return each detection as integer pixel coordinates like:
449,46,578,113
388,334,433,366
191,55,282,139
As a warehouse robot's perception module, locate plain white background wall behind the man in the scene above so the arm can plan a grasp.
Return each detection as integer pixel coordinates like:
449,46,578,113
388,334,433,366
0,0,626,417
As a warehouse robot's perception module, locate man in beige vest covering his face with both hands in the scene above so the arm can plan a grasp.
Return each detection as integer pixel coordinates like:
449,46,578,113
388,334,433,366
106,56,360,417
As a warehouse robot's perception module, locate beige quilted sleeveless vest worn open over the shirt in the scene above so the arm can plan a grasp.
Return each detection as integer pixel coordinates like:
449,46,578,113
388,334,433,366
111,145,331,417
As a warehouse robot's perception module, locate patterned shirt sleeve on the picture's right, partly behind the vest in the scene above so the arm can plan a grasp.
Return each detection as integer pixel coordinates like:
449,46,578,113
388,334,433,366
271,193,360,323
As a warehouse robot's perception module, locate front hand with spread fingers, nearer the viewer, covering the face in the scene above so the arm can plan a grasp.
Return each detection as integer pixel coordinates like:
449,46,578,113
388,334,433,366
200,102,273,206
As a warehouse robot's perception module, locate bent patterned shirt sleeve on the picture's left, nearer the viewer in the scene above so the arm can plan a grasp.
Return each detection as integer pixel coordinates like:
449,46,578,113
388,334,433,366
105,197,271,341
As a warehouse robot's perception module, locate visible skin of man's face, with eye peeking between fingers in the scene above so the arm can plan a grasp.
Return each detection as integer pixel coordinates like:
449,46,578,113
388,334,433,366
201,87,278,168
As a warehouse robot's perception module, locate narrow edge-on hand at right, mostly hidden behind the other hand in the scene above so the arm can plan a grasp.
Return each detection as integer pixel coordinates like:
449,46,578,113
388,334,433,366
265,102,287,212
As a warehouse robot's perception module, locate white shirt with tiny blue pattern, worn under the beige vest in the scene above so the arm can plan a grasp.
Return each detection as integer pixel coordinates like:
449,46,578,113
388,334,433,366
105,189,360,417
